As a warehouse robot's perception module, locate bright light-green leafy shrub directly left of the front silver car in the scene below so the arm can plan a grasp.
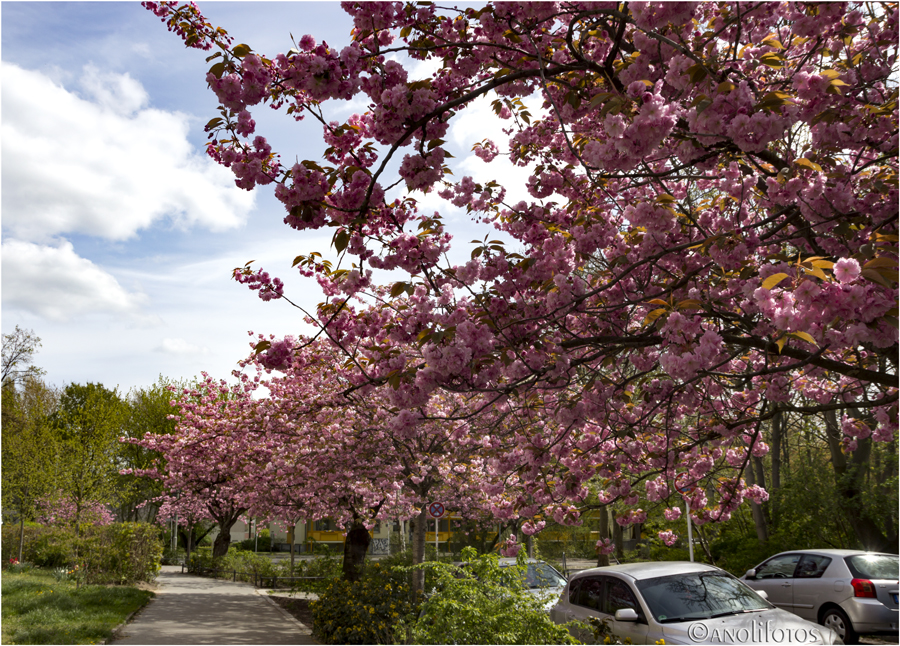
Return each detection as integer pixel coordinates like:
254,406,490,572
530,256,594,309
405,548,578,644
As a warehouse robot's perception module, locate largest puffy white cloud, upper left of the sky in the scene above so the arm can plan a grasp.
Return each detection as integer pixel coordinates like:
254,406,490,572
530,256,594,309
2,63,254,242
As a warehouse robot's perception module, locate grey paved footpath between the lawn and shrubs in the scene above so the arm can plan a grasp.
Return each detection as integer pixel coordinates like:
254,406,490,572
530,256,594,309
111,565,318,644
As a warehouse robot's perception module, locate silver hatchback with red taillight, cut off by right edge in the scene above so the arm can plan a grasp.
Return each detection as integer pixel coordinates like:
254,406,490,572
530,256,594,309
742,549,900,644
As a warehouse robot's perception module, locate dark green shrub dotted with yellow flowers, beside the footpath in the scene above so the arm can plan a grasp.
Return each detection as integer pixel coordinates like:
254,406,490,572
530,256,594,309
311,562,416,644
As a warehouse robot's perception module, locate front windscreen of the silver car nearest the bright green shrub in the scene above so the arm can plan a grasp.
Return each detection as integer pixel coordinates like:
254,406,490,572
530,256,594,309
636,572,772,623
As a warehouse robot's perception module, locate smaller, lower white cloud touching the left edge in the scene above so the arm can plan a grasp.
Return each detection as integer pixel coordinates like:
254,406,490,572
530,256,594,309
2,240,147,321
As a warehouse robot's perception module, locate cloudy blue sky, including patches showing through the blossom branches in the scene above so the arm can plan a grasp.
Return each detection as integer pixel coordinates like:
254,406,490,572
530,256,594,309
0,1,524,393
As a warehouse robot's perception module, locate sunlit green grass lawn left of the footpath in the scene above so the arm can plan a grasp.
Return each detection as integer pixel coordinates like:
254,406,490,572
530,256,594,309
0,569,153,644
